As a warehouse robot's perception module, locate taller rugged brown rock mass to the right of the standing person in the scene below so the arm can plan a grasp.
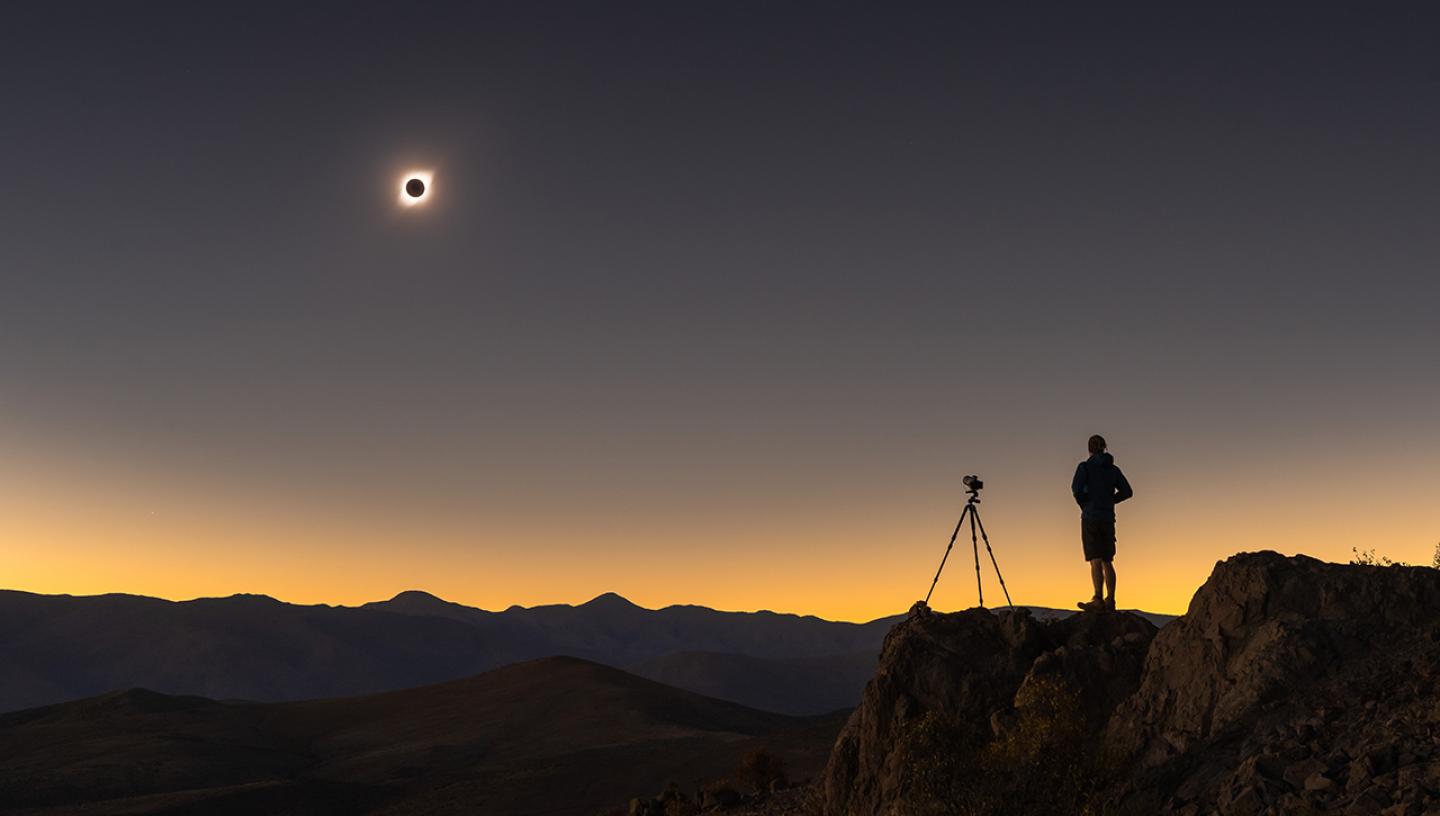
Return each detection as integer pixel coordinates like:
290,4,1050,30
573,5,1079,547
1106,553,1440,816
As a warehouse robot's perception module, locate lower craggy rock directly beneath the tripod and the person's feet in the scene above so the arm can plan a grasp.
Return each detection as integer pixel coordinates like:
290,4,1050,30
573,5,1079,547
821,604,1156,816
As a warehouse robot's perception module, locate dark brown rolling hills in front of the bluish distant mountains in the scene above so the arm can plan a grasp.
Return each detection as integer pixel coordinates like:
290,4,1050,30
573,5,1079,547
0,658,844,816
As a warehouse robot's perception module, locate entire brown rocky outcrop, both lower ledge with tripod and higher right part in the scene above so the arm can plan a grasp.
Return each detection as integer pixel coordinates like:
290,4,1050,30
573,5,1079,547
821,553,1440,816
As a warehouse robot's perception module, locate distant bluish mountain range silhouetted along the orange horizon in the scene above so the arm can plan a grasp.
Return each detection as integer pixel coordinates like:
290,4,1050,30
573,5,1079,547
0,590,1166,715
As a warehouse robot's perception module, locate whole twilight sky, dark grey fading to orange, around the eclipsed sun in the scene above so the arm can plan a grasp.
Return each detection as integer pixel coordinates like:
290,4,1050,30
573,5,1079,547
0,1,1440,620
